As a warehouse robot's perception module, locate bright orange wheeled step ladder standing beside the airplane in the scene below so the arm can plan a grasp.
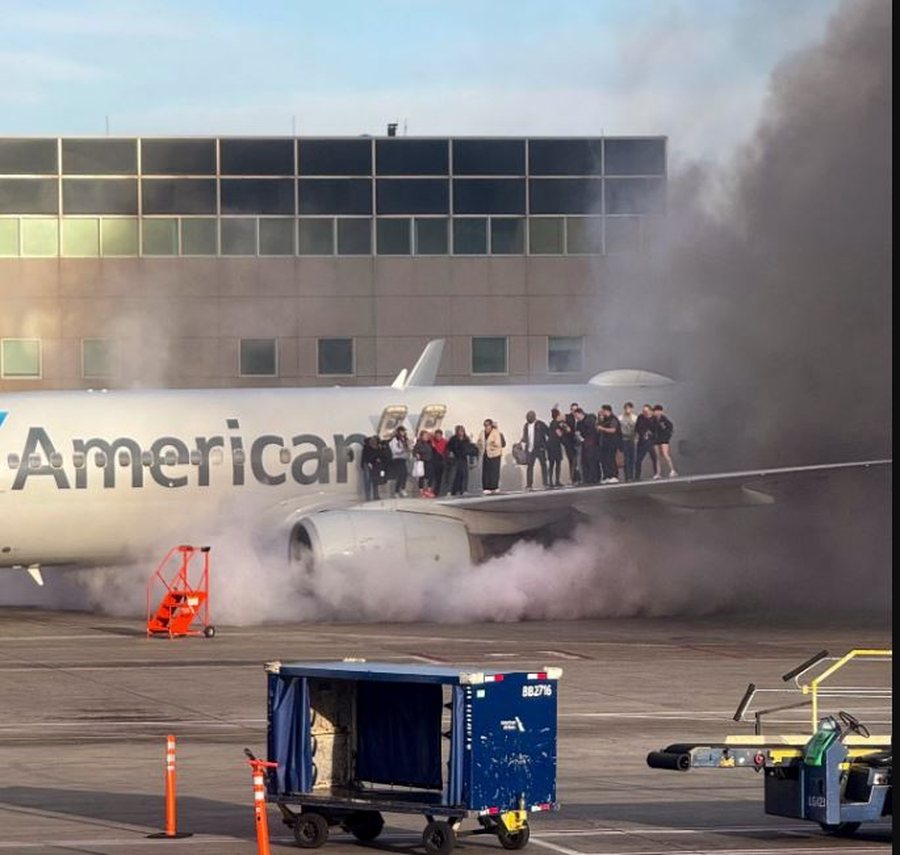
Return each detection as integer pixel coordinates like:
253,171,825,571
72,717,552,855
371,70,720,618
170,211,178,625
147,545,216,638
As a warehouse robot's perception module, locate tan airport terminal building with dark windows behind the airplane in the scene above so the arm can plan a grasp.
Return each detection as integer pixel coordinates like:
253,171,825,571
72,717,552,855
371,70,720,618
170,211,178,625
0,135,666,392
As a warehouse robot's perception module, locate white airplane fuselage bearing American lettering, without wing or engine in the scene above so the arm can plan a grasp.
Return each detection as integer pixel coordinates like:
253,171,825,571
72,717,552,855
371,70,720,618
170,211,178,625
0,385,672,567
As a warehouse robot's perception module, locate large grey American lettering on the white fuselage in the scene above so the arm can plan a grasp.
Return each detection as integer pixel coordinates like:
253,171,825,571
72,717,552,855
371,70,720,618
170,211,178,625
6,420,366,490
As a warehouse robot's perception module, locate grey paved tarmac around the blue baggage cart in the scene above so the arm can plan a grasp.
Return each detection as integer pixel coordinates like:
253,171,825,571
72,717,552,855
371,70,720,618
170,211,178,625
0,608,892,855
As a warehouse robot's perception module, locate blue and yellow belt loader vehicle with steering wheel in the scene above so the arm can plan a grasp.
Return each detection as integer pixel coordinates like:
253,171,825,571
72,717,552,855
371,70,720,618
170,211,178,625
647,650,893,835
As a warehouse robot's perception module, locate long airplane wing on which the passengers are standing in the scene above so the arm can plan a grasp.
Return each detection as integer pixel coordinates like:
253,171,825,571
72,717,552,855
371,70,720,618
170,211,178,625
437,460,892,514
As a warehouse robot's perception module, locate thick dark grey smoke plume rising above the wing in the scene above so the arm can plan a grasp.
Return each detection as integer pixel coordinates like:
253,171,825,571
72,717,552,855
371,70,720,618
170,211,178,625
600,0,892,466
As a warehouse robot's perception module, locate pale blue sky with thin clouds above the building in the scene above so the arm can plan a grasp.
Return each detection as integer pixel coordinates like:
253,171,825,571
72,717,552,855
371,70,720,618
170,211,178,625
0,0,838,163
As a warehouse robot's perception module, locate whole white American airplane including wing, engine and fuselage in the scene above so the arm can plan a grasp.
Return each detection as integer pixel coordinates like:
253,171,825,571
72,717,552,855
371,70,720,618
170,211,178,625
0,339,890,585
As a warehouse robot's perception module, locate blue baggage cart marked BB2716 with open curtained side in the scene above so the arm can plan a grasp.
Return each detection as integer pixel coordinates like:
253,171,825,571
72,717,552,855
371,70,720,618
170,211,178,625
266,660,562,855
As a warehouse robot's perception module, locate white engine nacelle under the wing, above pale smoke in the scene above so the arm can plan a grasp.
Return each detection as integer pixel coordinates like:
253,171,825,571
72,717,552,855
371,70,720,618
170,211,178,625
291,510,473,571
